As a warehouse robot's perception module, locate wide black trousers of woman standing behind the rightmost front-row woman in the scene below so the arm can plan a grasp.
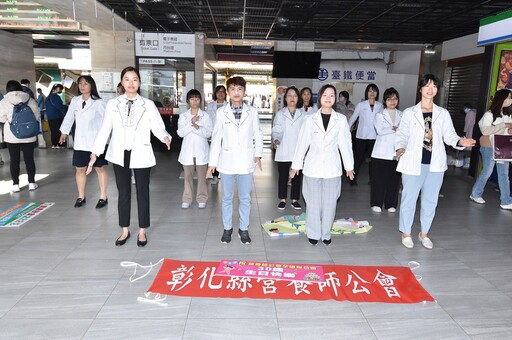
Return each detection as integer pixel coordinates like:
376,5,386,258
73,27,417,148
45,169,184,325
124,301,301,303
370,158,400,209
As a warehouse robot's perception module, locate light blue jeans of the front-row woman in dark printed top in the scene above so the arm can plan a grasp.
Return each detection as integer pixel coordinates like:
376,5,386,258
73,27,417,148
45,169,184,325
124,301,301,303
398,164,444,234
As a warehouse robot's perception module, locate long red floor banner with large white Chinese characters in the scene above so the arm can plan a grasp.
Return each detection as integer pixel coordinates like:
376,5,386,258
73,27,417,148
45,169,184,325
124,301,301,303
148,259,435,303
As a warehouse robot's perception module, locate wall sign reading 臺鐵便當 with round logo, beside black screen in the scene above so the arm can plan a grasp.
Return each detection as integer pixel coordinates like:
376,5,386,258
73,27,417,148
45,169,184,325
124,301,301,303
318,60,387,83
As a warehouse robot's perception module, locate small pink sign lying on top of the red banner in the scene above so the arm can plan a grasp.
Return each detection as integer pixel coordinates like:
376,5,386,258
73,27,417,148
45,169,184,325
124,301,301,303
216,260,324,282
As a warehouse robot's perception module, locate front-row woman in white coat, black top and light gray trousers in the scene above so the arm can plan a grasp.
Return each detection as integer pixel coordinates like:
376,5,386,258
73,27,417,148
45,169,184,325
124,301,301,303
290,85,354,245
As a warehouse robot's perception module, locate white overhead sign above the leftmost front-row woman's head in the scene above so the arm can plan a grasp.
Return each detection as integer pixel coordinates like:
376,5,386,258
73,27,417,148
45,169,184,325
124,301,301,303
135,32,195,58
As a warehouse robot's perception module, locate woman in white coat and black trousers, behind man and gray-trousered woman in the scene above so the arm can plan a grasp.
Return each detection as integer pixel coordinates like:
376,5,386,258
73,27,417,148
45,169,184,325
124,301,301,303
272,86,306,210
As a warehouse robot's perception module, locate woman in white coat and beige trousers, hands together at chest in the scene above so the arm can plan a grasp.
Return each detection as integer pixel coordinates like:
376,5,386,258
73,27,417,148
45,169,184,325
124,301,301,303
178,89,212,209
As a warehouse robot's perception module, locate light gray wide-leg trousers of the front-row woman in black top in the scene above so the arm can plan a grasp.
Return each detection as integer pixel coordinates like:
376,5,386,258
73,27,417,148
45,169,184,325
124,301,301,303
302,175,341,240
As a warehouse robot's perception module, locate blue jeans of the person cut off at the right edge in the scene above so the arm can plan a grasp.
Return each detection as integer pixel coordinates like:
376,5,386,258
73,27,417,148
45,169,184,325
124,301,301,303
471,146,512,205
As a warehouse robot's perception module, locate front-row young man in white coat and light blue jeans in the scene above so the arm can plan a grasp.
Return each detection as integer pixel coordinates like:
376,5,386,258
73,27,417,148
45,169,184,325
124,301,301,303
206,77,263,244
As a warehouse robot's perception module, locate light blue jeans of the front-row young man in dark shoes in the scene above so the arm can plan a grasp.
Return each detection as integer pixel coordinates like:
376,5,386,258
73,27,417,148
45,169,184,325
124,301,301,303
221,173,252,230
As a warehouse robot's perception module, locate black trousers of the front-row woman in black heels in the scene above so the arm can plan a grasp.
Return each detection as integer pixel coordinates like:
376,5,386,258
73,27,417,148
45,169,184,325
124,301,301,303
114,150,151,228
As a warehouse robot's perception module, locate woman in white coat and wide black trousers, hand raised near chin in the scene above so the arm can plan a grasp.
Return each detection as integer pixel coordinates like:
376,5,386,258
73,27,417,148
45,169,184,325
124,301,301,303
370,87,402,212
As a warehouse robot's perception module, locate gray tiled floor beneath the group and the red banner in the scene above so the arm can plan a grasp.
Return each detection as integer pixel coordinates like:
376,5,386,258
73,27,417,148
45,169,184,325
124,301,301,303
0,149,512,339
